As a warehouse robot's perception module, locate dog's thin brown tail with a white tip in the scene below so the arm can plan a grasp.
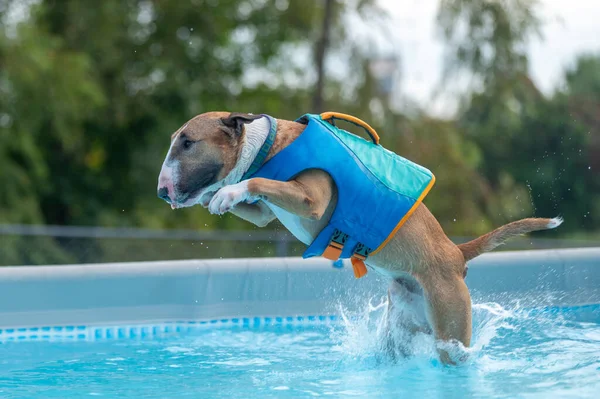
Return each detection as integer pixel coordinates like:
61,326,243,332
458,217,563,262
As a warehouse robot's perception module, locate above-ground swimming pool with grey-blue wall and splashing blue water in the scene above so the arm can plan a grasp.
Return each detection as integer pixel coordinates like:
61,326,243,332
0,249,600,398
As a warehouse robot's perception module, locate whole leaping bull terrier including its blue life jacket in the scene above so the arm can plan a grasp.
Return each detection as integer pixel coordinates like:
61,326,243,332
158,112,562,364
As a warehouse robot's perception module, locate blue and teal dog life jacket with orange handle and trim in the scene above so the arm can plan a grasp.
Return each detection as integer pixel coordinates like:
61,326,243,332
249,113,435,277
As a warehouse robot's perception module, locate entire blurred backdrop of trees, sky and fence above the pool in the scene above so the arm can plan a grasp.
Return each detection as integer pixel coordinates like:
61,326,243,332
0,0,600,265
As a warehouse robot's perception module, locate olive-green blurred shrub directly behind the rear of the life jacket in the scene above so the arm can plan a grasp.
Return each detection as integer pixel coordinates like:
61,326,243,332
397,118,531,236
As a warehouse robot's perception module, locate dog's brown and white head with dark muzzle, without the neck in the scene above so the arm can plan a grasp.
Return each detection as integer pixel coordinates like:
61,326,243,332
158,112,261,209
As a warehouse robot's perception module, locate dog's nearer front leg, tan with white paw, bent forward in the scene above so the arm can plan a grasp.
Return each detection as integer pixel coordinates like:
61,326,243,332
208,170,332,220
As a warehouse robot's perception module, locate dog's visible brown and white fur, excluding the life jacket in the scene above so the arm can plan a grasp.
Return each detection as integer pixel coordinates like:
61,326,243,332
158,112,562,363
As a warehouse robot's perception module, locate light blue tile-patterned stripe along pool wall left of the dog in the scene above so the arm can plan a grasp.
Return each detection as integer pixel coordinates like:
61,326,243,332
0,315,340,343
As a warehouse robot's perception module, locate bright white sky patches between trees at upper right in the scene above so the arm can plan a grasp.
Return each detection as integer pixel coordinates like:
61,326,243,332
378,0,600,116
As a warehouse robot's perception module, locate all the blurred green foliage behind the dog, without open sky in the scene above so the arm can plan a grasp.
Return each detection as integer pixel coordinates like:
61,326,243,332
0,0,600,264
